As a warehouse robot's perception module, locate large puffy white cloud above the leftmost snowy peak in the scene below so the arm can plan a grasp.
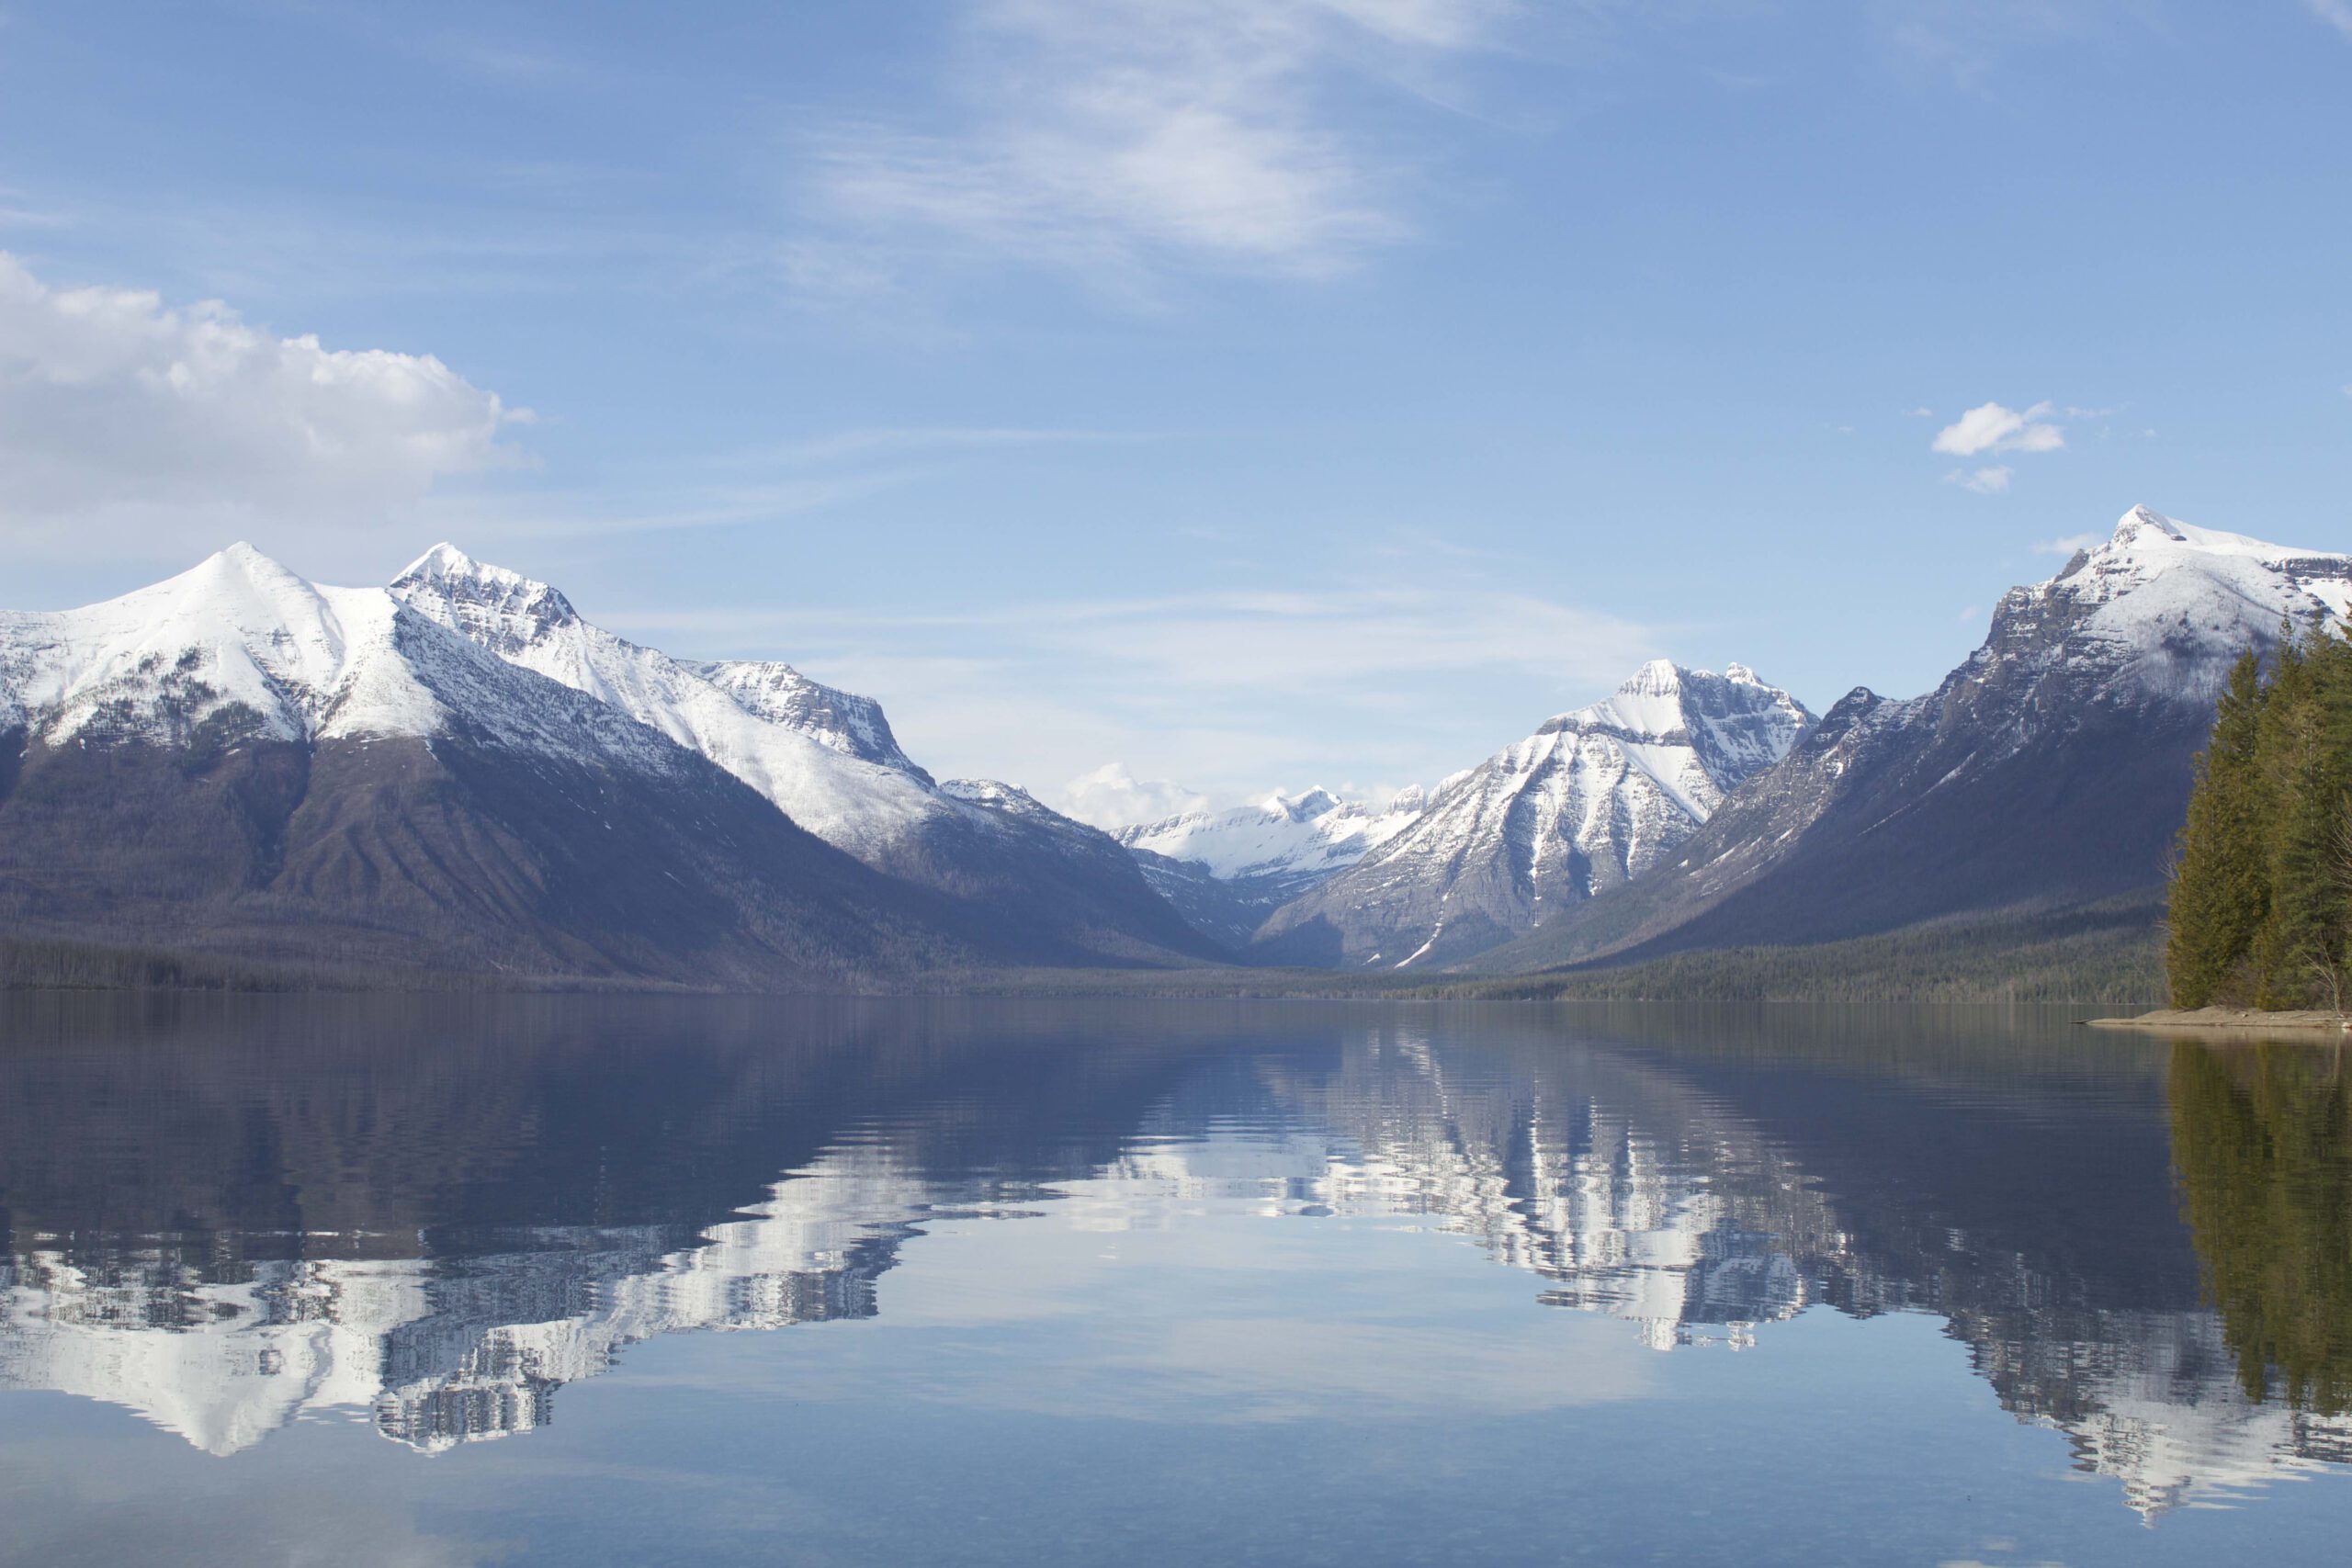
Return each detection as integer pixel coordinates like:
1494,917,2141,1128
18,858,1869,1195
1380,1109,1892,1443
0,252,529,558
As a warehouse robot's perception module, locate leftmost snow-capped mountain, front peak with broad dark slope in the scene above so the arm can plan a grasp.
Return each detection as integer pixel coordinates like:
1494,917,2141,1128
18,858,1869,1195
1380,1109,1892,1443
0,546,986,987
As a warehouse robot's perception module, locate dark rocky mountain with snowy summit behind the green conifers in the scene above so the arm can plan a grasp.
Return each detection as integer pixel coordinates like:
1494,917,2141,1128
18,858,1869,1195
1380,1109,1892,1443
1482,505,2352,968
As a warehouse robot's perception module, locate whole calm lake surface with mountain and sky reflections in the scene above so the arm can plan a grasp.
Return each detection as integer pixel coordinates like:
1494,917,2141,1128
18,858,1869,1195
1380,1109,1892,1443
0,997,2352,1568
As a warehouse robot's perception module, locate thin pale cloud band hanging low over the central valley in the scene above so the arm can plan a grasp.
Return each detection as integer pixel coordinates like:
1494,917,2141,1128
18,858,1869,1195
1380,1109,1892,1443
616,573,1665,802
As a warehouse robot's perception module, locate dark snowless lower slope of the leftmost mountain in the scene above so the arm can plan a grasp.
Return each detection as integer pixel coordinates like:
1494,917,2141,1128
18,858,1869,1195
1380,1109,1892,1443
0,736,974,987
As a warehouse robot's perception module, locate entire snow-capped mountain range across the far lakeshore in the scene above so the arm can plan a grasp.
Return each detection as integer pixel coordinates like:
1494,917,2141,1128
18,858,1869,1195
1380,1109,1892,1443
0,508,2352,989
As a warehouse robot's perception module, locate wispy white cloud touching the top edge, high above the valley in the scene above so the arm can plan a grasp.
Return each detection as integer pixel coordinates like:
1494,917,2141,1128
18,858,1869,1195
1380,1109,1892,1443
807,0,1517,291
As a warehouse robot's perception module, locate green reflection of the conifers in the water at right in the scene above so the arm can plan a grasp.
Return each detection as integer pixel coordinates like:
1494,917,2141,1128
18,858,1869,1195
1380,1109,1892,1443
2168,1043,2352,1416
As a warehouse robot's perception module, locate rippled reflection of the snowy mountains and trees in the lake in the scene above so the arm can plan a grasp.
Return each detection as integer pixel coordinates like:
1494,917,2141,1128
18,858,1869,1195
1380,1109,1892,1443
0,999,2352,1517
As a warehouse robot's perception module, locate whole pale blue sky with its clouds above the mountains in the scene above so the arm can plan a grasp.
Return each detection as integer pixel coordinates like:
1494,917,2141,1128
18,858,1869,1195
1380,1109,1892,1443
0,0,2352,820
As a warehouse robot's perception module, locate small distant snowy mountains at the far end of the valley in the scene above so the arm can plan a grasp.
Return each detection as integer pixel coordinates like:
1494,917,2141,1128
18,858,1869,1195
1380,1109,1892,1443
1113,785,1428,947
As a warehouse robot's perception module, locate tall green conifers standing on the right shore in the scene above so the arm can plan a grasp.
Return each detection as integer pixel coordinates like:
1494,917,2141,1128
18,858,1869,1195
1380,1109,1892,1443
2164,632,2352,1009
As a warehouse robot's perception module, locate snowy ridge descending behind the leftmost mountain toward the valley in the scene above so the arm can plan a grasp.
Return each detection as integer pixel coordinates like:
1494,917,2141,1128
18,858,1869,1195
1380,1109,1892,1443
390,546,1223,964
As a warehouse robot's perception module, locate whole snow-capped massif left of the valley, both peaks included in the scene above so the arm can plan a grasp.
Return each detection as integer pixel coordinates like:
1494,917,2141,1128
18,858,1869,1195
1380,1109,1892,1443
0,546,1214,987
